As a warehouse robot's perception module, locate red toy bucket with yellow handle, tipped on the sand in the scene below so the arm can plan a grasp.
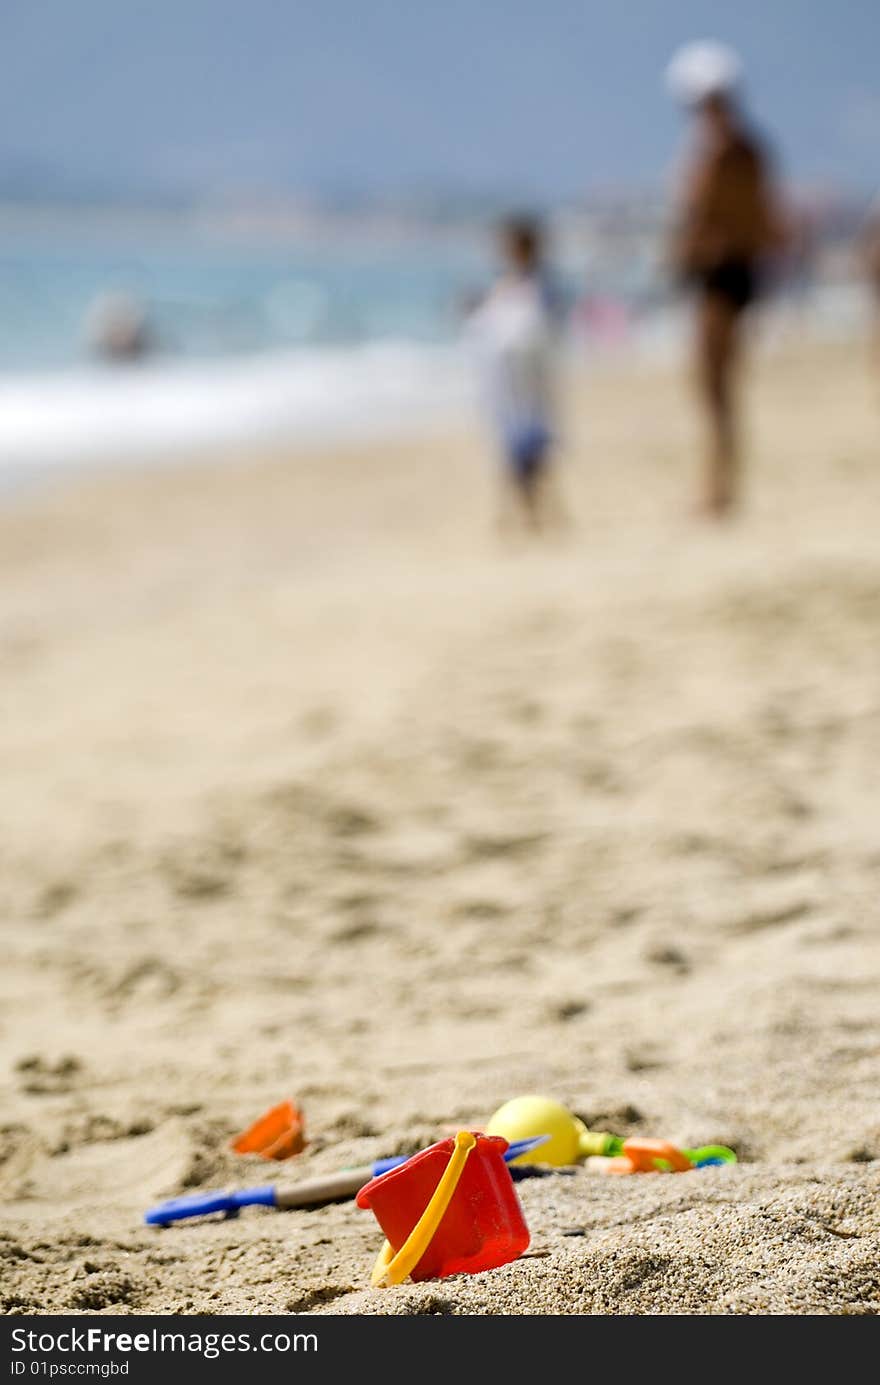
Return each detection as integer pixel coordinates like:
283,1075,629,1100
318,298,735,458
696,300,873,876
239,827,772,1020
356,1130,529,1288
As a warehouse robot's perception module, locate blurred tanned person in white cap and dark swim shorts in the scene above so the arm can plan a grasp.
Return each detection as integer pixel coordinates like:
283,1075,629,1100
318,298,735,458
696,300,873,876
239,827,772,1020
667,42,786,518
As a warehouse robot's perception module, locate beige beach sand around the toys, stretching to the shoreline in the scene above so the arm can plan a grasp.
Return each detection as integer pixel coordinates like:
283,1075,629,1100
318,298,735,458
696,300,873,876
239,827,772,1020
0,340,880,1314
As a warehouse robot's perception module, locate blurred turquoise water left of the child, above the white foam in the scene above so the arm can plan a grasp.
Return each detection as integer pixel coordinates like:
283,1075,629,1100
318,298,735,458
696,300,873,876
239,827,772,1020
0,217,491,373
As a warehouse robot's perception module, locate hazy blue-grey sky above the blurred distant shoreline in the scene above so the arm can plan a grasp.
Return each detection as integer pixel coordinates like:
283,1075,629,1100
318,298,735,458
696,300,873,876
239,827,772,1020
0,0,880,201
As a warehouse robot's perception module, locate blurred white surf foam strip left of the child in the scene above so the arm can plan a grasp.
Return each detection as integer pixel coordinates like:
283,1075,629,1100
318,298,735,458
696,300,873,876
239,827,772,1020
0,343,471,470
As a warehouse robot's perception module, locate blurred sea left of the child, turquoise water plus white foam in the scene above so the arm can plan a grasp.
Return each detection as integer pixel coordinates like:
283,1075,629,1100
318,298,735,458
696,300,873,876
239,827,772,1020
0,213,501,471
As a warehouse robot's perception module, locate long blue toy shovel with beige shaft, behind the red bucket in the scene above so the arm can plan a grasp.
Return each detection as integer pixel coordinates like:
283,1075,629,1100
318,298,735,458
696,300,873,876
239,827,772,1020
144,1136,543,1226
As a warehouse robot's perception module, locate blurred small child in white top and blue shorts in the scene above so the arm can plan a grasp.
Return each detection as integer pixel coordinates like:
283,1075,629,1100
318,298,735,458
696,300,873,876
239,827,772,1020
468,217,561,530
